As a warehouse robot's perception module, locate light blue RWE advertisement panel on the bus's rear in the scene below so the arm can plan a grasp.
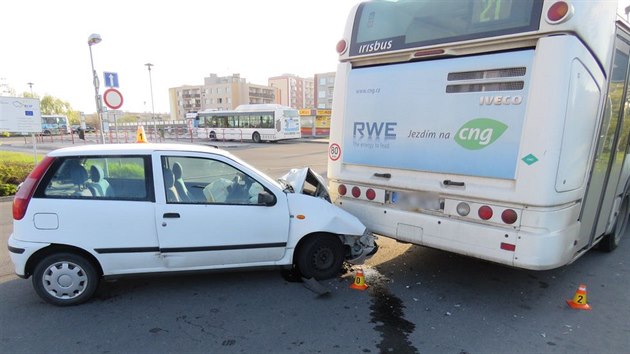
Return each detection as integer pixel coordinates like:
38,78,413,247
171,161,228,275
343,51,533,179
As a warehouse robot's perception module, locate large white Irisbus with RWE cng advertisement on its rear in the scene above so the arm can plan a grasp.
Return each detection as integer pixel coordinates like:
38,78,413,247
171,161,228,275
328,0,630,270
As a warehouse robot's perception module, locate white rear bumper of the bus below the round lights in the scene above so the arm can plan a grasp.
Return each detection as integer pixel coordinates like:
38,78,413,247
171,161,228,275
335,199,580,270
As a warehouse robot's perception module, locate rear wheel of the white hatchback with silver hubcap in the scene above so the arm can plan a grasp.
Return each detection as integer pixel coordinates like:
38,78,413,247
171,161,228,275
33,253,99,306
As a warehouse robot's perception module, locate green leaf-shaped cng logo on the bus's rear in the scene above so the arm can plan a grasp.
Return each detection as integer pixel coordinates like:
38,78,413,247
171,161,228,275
455,118,508,150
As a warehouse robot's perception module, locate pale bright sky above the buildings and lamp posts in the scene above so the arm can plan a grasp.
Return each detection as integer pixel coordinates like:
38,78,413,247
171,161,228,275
0,0,359,113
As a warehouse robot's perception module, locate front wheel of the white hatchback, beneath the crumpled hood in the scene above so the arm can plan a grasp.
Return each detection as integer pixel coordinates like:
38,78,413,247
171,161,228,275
296,234,344,280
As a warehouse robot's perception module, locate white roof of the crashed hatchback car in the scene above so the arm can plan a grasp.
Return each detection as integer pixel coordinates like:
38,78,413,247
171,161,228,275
48,143,232,157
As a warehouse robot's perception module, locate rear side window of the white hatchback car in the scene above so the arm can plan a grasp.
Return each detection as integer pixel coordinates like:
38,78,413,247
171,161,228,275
41,156,152,201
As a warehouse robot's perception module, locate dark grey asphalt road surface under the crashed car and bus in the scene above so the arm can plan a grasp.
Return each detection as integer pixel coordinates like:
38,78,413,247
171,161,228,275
0,143,630,353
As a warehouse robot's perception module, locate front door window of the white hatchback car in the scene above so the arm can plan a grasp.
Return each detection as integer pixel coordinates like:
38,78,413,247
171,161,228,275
162,156,265,205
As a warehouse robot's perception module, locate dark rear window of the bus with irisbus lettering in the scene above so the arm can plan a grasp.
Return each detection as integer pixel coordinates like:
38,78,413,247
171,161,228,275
350,0,543,56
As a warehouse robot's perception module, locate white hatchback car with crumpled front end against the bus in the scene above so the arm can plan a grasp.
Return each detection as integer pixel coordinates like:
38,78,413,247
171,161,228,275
8,144,376,306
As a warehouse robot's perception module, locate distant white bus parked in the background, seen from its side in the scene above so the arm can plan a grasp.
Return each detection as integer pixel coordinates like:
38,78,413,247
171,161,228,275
197,104,302,143
